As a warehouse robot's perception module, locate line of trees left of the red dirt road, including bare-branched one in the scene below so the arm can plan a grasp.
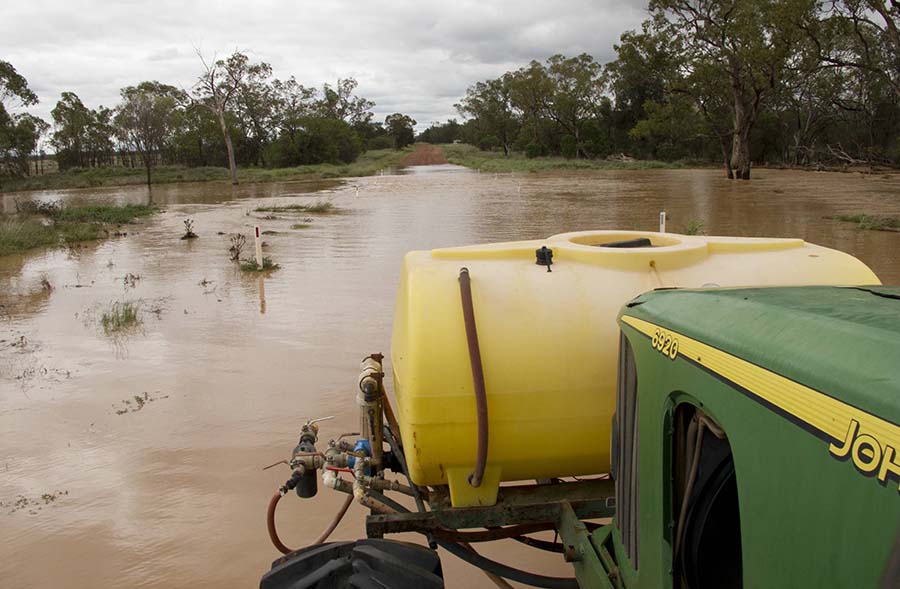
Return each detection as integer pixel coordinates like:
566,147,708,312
0,52,415,184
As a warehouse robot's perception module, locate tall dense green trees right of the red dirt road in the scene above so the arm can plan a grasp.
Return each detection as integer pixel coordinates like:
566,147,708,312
430,0,900,179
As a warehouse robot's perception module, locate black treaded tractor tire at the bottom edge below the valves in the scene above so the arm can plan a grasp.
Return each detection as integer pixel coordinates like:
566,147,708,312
259,539,444,589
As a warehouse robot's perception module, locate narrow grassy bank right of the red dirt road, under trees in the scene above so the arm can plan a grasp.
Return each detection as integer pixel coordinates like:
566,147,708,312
441,144,685,173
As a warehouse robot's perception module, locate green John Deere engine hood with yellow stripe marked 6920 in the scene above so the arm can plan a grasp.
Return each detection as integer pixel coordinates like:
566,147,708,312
604,287,900,589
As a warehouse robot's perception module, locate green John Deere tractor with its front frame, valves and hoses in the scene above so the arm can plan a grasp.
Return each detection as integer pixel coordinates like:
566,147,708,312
261,233,900,589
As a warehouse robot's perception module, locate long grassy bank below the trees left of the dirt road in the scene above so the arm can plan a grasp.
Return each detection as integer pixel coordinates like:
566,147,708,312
0,148,411,192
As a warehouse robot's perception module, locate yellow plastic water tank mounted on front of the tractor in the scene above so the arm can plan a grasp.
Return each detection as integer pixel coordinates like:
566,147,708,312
391,231,880,506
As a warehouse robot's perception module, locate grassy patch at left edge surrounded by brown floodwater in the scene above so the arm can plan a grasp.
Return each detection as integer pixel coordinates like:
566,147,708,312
0,205,156,256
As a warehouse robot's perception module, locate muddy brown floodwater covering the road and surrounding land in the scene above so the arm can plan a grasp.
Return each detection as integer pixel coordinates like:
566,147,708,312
0,165,900,587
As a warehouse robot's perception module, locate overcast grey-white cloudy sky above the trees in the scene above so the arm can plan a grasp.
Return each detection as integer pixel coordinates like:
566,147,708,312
0,0,646,130
